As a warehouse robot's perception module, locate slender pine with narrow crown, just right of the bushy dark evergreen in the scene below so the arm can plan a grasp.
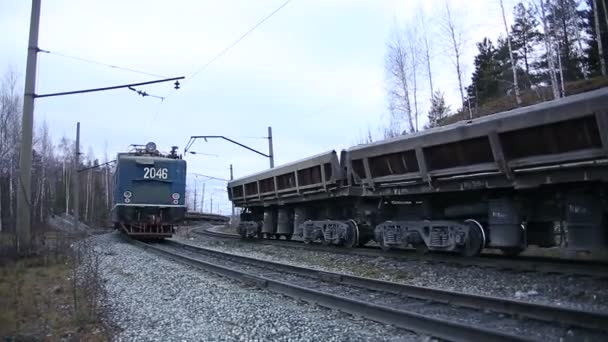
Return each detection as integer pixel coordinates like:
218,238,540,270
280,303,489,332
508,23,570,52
511,2,541,87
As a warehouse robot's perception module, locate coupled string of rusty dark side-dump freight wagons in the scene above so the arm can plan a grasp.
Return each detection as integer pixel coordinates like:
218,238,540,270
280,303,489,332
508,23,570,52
228,88,608,255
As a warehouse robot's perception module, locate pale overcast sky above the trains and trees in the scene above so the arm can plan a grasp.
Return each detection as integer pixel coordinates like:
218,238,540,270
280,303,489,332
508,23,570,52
0,0,516,213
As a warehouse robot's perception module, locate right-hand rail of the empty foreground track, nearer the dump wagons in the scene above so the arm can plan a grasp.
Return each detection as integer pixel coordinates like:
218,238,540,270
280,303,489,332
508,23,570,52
167,241,608,332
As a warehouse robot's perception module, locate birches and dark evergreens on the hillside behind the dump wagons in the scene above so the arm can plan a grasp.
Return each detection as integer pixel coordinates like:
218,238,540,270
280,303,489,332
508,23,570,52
382,0,608,141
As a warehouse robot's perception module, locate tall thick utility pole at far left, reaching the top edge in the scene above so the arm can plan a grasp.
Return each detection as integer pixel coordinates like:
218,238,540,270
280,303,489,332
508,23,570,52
16,0,40,254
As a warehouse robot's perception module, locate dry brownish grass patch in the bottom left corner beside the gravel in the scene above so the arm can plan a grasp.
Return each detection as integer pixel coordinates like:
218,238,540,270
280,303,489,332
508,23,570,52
0,234,109,341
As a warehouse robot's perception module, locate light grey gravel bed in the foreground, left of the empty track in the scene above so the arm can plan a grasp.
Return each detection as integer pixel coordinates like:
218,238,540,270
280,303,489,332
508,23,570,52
92,233,420,341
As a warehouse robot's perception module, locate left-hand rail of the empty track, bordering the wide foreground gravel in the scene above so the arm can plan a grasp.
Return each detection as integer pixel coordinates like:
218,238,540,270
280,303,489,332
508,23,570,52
132,241,532,341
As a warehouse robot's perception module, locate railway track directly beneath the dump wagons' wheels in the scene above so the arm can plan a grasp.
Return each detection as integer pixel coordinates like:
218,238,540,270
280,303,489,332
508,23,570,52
192,228,608,278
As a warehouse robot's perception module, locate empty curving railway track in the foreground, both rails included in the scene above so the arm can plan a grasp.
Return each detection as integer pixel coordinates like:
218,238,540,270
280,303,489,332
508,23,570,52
134,241,608,341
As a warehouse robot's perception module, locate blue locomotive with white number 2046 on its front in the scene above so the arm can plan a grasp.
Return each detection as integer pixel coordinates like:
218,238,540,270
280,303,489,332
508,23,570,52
112,142,186,238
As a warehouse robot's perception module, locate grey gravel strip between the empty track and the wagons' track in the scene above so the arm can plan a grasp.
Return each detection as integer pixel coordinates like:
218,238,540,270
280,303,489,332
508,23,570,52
176,226,608,312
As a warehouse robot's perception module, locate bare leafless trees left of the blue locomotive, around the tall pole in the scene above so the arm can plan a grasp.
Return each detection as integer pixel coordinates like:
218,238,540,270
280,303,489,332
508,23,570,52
0,69,113,232
